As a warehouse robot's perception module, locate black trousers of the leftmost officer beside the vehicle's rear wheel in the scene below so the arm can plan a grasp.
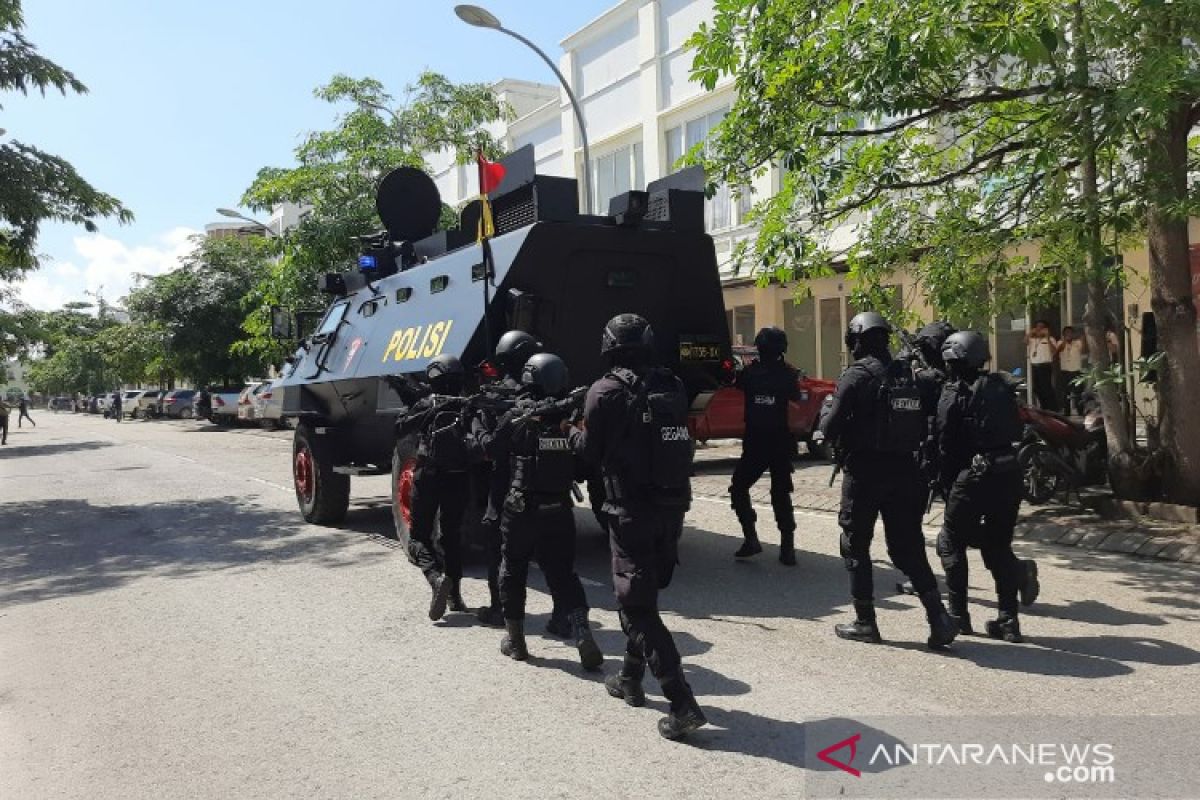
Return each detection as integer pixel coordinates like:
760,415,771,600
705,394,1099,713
408,467,470,579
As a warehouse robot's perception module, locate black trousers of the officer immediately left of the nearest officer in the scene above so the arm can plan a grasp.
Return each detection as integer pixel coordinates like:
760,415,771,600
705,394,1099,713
500,495,588,620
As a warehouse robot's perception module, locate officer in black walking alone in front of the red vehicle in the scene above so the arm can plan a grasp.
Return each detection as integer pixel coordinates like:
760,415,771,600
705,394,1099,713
730,327,800,566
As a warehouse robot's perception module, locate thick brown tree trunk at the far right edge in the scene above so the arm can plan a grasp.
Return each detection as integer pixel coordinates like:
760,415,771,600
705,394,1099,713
1146,98,1200,505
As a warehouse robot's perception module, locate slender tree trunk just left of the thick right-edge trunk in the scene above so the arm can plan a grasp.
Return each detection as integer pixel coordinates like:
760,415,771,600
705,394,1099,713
1073,0,1142,498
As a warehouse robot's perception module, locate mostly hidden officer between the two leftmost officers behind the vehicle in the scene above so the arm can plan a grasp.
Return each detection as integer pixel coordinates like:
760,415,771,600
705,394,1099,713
472,330,542,633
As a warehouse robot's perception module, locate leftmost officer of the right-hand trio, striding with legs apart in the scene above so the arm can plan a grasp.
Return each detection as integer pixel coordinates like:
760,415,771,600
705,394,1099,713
821,312,958,649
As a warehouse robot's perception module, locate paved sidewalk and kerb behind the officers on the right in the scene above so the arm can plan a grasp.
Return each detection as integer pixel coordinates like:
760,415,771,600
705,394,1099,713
692,441,1200,564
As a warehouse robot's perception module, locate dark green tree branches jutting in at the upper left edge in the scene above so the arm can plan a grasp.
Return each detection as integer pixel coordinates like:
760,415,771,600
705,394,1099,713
0,0,133,281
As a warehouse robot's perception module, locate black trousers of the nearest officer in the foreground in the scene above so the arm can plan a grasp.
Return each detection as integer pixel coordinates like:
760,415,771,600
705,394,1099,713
608,509,691,708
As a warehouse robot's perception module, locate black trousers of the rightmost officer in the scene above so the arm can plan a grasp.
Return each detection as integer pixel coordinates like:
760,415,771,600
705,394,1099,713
937,469,1021,616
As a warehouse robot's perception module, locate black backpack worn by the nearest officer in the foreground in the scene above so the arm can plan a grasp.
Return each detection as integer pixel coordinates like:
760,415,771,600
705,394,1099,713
608,368,696,506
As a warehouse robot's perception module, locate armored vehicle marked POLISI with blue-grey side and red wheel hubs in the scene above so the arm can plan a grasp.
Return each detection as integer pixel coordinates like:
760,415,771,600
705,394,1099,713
276,148,732,535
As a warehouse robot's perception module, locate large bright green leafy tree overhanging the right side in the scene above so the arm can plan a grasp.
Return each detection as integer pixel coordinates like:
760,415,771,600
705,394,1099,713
692,0,1200,501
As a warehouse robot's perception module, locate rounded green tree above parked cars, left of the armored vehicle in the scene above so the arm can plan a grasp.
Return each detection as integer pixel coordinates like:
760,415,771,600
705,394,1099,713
126,236,275,384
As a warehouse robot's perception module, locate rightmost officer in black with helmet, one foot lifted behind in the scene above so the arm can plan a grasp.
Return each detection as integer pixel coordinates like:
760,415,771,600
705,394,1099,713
936,331,1039,642
